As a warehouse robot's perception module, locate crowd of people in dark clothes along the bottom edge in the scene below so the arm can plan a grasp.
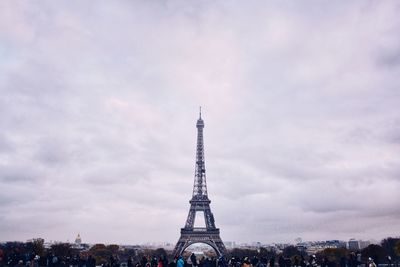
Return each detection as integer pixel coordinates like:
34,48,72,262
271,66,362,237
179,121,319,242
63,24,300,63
0,253,396,267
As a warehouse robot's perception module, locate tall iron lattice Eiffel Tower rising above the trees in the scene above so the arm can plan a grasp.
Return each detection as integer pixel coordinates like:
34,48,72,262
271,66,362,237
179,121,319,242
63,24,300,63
173,108,226,256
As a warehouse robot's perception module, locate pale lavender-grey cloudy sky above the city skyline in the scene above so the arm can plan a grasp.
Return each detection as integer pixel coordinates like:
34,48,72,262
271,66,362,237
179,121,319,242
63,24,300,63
0,1,400,244
